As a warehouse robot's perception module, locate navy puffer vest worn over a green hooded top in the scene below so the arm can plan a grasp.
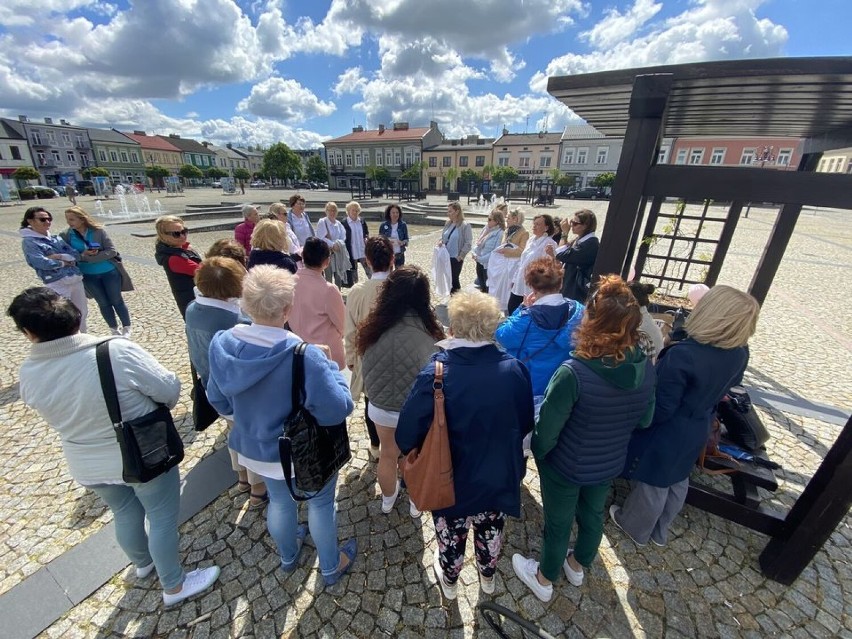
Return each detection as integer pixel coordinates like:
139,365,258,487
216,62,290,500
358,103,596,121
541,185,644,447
546,359,656,486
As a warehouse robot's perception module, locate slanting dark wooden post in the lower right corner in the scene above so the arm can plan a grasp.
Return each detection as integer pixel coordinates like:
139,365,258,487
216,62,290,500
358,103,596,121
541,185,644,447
760,417,852,586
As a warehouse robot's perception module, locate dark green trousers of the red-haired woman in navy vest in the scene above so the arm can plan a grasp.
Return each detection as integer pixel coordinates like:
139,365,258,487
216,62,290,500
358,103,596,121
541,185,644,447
537,461,612,581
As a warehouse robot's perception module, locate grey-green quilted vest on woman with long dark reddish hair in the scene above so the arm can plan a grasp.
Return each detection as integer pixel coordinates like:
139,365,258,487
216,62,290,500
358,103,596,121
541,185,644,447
361,313,438,412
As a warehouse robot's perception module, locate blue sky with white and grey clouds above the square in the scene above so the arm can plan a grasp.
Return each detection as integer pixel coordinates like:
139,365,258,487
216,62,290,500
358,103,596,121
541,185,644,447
0,0,852,149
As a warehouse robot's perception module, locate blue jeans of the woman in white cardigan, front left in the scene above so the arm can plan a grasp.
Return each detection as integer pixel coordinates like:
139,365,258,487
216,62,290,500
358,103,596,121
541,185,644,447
90,466,184,590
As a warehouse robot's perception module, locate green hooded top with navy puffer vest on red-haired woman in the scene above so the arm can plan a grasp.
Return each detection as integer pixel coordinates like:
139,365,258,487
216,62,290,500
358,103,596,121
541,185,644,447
532,348,656,485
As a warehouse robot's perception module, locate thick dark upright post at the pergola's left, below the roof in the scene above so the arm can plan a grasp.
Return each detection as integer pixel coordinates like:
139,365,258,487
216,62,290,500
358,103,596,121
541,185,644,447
594,73,673,277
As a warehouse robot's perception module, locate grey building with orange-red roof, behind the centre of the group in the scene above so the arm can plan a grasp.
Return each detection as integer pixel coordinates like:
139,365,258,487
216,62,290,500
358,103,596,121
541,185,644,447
323,122,443,189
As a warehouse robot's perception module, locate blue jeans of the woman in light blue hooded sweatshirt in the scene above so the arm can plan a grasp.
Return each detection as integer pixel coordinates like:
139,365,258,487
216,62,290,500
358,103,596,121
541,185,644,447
264,473,340,576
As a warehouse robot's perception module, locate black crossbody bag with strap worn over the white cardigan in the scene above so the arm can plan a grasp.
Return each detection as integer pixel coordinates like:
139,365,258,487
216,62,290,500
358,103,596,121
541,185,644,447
95,340,183,484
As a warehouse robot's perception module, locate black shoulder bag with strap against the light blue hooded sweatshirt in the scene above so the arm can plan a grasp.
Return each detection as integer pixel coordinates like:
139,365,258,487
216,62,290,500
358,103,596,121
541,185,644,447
278,342,352,501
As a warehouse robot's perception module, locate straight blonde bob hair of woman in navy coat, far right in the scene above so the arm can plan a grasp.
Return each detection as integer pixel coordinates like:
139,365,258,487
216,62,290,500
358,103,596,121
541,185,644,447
684,284,760,348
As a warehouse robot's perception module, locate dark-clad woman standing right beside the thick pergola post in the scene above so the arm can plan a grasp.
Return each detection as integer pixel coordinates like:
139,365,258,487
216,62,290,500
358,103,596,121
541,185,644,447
547,209,600,303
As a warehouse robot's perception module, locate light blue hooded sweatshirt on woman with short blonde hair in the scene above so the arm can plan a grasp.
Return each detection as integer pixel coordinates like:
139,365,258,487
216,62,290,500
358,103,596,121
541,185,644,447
207,324,354,463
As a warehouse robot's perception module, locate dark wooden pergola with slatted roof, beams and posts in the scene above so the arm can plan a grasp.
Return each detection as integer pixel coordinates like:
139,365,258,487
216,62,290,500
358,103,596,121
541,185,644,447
547,57,852,584
